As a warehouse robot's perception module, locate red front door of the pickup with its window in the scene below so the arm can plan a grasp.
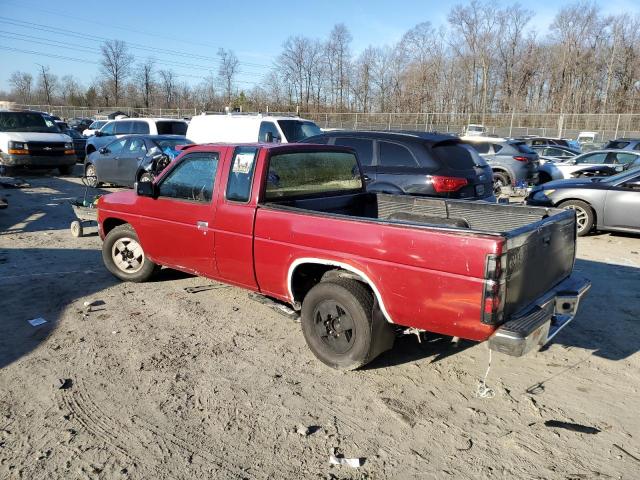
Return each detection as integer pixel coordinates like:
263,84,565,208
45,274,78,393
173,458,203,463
137,151,221,277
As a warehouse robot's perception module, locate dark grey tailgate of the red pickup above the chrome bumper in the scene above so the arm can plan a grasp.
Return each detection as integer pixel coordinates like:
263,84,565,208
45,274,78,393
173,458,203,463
504,211,576,318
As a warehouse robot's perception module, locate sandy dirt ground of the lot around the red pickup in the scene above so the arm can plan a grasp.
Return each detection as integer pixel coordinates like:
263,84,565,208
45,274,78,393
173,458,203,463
0,171,640,479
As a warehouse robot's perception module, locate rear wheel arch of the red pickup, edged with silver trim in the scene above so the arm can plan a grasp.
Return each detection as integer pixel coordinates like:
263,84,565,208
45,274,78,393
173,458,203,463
287,258,394,323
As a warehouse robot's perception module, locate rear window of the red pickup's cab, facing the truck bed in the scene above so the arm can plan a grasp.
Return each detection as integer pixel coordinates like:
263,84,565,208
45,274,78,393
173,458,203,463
265,152,362,200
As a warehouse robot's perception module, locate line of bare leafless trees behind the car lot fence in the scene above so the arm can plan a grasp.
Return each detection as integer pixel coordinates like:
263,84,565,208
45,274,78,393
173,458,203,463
2,0,640,113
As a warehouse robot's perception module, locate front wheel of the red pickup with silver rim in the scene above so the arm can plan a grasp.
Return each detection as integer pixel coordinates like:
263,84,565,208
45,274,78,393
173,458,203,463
102,224,160,283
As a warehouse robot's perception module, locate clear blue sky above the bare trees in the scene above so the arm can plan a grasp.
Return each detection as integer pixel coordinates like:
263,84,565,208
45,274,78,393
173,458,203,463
0,0,640,91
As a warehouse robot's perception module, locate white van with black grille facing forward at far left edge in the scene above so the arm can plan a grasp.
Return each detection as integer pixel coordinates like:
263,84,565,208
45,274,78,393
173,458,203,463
0,110,76,175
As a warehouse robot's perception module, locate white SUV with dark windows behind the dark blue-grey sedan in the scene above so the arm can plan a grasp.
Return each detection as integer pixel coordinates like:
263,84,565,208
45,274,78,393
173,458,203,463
86,118,187,155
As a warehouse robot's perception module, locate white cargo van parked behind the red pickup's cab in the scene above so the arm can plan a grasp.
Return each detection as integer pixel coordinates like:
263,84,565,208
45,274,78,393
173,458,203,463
187,113,322,143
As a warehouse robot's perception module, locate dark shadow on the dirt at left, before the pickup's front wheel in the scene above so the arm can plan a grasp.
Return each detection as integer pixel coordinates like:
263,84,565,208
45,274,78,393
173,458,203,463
0,248,117,369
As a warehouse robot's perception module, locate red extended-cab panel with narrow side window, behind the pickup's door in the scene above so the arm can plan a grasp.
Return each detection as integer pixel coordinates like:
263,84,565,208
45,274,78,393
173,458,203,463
216,147,258,289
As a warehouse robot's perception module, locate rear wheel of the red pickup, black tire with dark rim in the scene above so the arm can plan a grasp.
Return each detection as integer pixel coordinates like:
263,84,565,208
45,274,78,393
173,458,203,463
301,279,375,370
